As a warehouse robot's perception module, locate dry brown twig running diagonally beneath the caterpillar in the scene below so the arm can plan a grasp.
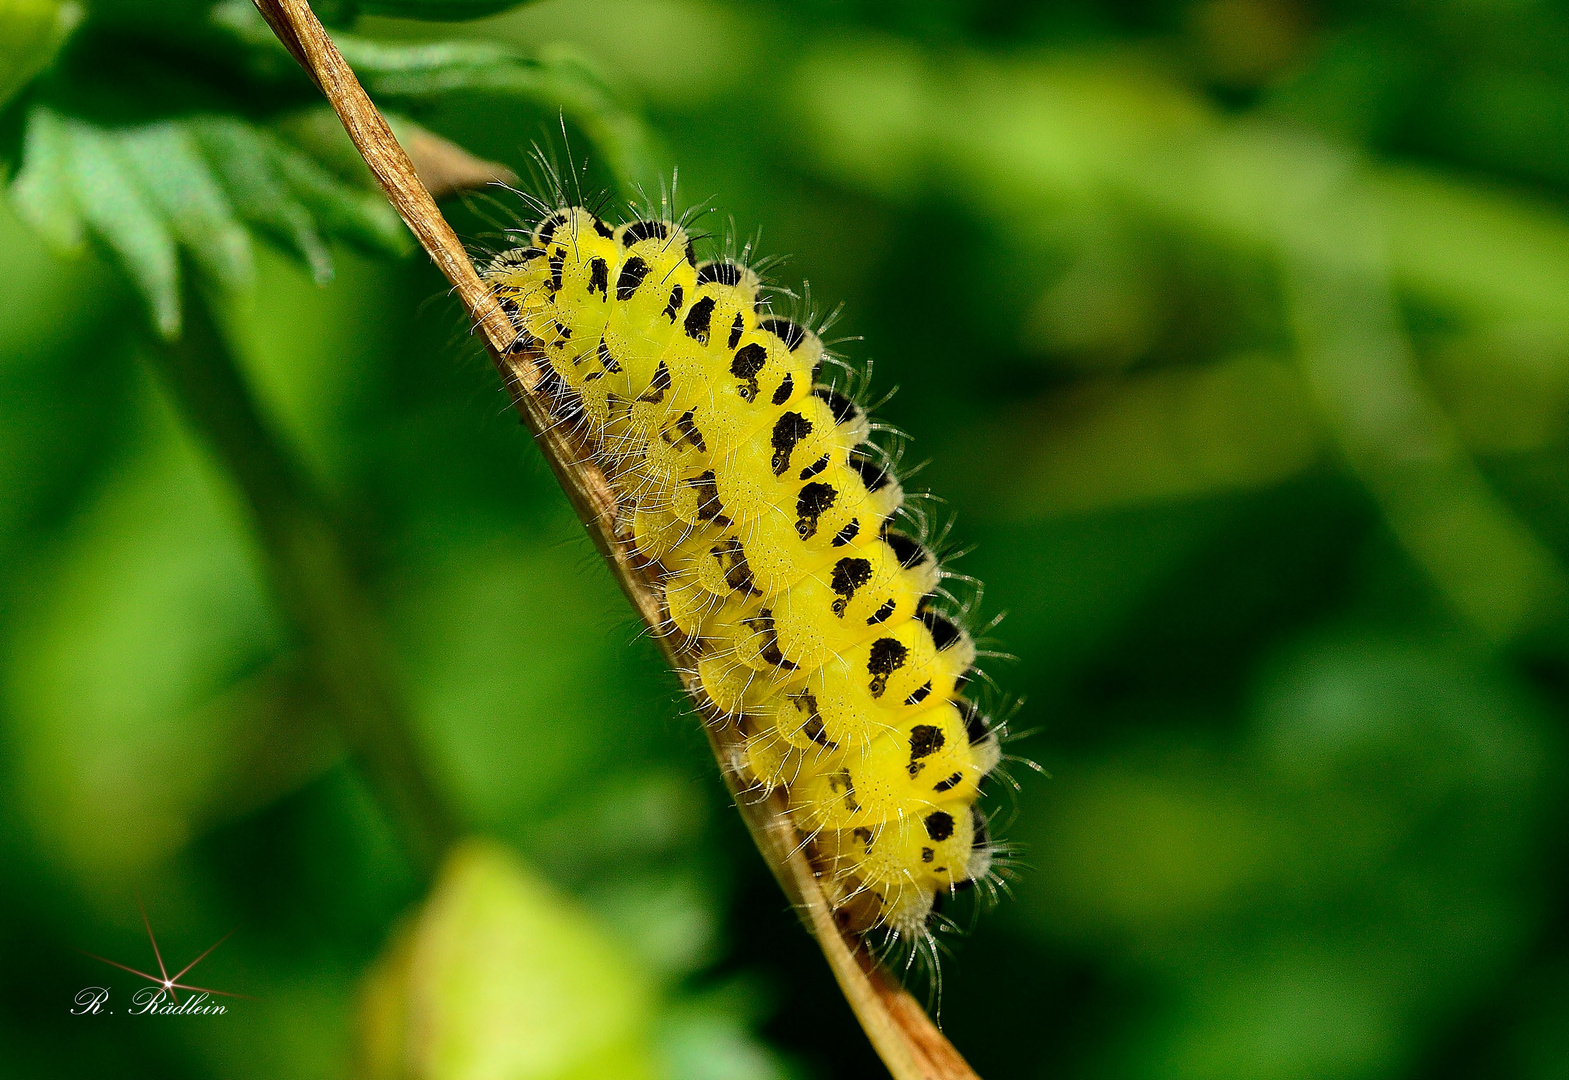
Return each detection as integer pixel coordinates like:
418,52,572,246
244,0,979,1080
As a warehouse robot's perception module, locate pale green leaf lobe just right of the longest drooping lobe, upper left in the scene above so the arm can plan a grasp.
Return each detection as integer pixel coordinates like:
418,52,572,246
119,122,256,290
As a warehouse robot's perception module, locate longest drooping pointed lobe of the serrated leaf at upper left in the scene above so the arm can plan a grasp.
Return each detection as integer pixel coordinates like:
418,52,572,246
66,119,180,338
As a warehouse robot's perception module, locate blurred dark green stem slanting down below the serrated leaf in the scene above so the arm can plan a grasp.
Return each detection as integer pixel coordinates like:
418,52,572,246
149,276,457,876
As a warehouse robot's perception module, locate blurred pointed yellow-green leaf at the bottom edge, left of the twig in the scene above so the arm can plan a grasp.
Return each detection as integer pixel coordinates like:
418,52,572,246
361,841,654,1080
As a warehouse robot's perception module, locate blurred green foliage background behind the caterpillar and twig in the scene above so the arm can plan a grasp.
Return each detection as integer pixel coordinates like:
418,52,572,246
9,0,1569,1080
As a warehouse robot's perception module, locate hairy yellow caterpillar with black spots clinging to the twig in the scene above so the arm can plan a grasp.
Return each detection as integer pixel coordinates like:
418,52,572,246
480,207,999,940
